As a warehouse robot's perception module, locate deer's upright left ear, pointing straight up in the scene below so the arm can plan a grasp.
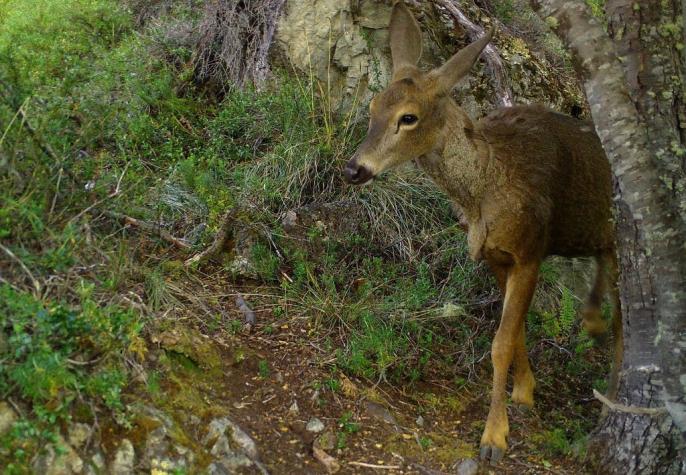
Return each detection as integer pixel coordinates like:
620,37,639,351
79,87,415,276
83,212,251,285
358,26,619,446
389,0,422,76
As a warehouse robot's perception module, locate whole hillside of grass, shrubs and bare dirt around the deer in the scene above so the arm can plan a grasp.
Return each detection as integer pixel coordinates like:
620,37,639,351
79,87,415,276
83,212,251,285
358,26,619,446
0,0,608,474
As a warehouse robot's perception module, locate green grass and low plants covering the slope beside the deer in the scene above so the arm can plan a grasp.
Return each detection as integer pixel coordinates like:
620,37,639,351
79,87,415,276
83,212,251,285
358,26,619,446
0,0,612,473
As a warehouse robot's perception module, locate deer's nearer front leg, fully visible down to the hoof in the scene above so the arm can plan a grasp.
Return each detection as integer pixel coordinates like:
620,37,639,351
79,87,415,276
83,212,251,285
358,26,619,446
481,261,540,464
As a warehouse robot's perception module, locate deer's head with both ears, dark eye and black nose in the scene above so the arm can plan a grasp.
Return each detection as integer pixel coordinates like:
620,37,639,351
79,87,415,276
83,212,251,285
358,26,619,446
343,1,493,185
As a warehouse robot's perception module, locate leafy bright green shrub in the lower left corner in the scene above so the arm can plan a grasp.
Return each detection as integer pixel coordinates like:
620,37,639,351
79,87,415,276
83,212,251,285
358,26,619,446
0,281,146,472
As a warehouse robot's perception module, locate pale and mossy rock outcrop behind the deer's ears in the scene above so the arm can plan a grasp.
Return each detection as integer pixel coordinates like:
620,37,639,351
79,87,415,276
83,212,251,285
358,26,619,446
276,0,583,117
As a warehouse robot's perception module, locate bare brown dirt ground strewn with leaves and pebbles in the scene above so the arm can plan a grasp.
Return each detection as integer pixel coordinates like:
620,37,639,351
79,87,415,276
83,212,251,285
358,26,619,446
103,260,599,474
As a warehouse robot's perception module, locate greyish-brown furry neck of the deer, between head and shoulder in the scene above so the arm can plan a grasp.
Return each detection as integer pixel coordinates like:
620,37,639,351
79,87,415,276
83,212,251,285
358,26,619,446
418,100,492,222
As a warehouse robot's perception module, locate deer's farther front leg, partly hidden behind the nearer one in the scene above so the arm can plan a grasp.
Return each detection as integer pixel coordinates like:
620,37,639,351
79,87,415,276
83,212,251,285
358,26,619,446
489,263,536,408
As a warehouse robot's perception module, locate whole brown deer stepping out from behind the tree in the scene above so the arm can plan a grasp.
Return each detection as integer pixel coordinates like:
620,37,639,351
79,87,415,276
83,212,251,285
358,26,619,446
344,2,622,463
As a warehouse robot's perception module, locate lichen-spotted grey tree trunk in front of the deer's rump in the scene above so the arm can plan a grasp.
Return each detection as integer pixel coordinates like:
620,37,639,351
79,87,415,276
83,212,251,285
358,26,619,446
533,0,686,474
